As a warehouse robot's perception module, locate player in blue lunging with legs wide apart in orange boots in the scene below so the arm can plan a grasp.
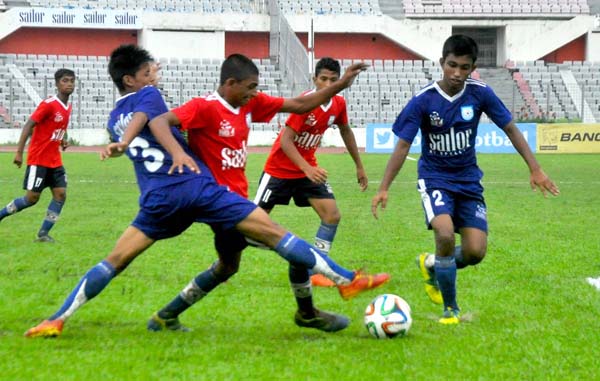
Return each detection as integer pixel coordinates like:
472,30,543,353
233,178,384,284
25,45,384,337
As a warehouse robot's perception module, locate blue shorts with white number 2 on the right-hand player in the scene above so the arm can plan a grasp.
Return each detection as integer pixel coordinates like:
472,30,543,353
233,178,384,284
417,179,488,233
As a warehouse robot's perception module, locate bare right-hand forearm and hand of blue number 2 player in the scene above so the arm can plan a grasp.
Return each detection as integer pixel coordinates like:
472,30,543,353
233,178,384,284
503,121,560,197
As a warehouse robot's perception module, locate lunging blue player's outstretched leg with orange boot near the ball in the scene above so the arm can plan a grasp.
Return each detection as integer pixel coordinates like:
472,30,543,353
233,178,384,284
236,208,389,299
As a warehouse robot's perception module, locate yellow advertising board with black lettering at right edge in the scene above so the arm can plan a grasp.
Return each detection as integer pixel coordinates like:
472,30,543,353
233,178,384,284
537,123,600,153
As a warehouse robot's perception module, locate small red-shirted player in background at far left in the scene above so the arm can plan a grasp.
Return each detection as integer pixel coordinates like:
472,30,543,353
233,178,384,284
0,69,75,242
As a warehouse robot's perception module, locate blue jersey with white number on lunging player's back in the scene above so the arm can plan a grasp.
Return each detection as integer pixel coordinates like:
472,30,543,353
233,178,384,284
108,86,213,195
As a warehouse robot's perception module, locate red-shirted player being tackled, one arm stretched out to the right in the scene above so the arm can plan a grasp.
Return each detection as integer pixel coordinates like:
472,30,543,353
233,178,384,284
148,54,389,332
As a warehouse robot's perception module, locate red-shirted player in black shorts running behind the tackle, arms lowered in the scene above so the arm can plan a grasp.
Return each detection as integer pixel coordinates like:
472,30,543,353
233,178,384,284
254,57,368,287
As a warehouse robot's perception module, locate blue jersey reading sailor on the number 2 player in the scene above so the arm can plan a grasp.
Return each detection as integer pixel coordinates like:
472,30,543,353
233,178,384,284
392,79,512,181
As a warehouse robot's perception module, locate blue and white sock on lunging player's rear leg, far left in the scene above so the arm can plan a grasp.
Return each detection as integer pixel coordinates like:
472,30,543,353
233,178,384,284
48,261,115,320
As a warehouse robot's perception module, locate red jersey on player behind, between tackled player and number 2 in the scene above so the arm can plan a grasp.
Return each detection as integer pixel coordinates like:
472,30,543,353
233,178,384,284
265,90,348,179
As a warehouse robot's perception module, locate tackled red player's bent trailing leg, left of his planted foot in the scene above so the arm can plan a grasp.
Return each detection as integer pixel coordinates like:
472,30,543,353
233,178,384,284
147,229,248,331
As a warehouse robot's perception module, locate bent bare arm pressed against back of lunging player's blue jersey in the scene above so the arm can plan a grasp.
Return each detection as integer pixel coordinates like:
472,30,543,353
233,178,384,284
148,111,200,174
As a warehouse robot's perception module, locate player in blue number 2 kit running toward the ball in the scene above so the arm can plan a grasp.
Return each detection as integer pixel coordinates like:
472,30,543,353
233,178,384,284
371,35,559,324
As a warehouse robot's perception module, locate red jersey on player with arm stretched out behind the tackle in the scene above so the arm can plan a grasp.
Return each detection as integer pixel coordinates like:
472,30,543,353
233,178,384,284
172,92,283,198
